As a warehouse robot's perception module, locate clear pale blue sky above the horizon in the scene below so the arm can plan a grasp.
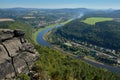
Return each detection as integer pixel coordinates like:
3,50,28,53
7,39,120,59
0,0,120,9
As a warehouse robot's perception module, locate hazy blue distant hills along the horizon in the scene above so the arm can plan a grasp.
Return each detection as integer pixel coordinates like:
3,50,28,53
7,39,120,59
0,8,120,18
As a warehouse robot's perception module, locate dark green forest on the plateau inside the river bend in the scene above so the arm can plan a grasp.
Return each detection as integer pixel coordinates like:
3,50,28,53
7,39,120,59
55,20,120,50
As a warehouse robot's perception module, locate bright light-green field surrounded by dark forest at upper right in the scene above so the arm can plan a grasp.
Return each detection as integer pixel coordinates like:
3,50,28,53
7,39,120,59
82,17,113,25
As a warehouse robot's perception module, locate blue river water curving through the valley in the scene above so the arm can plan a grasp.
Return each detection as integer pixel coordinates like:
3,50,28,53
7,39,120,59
36,24,120,73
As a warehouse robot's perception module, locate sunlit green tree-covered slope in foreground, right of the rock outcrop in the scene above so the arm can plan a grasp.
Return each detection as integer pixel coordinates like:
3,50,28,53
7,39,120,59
33,46,120,80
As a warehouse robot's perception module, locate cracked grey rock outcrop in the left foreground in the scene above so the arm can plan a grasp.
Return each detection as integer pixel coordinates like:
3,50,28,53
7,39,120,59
0,29,39,80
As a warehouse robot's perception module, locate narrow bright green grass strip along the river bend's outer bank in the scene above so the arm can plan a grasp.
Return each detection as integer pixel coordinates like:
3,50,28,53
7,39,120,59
32,20,71,44
